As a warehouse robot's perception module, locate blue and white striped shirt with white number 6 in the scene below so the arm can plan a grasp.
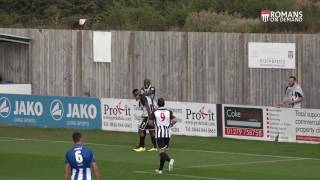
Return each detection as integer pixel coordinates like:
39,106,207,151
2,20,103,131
65,144,96,180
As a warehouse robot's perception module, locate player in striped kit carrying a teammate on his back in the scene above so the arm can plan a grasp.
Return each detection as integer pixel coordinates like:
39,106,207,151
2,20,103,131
132,89,157,152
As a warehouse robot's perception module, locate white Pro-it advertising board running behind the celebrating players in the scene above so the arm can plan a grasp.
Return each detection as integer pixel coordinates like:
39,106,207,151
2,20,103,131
101,98,217,137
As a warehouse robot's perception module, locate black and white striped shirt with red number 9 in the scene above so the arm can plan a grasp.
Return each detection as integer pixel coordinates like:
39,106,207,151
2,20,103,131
152,107,175,138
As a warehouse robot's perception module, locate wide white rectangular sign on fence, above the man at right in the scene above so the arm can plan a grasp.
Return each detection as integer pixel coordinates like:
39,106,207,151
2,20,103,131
248,42,296,69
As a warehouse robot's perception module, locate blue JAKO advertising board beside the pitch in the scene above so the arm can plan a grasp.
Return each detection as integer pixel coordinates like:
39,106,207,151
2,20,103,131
0,94,101,129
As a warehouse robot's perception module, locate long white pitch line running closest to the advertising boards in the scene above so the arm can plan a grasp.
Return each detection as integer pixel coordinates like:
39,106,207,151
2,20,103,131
0,137,320,160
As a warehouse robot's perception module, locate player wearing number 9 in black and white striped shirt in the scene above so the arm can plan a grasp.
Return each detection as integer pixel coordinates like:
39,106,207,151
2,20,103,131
150,98,177,174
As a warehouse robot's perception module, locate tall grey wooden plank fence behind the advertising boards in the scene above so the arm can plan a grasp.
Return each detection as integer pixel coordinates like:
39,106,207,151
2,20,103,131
0,29,320,108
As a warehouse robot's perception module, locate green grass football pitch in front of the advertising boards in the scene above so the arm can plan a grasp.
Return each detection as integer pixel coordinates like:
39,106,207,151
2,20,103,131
0,127,320,180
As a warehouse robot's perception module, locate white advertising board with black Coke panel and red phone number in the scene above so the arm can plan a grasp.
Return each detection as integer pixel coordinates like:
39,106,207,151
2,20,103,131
222,105,320,143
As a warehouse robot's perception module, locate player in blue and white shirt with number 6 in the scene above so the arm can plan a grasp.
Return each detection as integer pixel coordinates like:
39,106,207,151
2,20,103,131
64,132,100,180
